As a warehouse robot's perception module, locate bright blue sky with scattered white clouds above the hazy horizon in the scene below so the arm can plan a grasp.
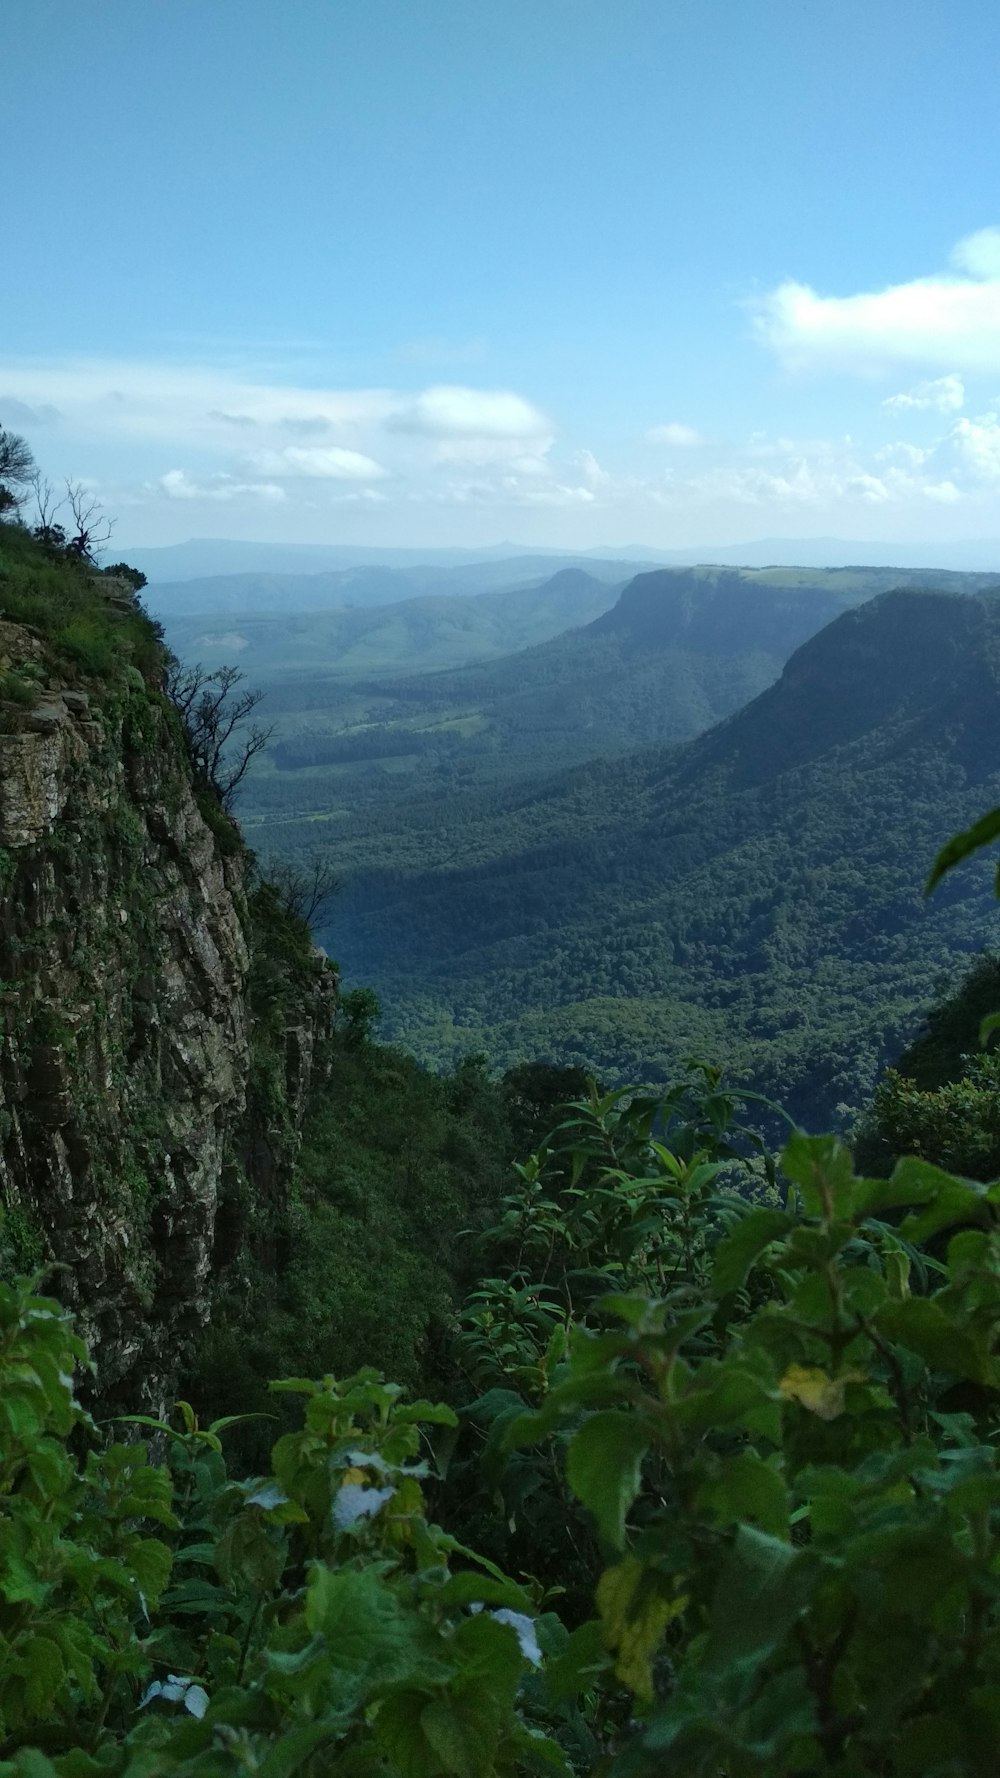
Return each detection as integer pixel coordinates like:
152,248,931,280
0,0,1000,549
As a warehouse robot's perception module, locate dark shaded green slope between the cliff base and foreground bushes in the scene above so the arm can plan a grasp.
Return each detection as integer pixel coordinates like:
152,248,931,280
185,1031,530,1463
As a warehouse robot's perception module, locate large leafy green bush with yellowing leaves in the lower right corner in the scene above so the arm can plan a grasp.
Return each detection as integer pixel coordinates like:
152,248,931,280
451,1101,1000,1778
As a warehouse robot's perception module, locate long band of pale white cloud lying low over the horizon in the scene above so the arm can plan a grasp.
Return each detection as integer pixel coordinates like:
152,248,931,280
0,337,1000,542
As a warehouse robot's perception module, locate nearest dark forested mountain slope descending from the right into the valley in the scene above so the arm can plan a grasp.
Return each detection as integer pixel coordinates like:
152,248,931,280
329,590,1000,1122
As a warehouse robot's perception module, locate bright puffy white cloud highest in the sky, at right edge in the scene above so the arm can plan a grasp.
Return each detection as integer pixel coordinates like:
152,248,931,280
753,228,1000,372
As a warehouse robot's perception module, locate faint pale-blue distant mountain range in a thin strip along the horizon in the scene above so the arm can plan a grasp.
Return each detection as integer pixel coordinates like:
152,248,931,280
126,537,1000,583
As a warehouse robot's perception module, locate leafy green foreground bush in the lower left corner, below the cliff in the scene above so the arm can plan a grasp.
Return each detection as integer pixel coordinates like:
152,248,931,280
0,1282,568,1778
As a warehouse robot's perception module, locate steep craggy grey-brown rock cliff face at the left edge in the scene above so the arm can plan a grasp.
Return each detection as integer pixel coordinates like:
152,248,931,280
0,604,331,1406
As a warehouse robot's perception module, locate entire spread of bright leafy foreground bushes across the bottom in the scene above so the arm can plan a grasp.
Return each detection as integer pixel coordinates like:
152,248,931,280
9,1106,1000,1778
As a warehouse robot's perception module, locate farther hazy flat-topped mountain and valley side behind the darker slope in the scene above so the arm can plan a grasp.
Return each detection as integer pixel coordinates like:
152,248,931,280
229,567,991,866
